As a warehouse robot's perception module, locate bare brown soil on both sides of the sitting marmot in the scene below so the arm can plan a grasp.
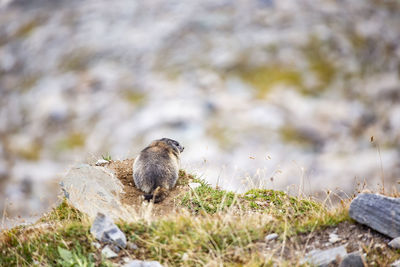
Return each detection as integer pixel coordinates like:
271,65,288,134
104,159,193,216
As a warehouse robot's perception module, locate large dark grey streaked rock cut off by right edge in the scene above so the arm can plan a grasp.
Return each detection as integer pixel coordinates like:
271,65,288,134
349,193,400,238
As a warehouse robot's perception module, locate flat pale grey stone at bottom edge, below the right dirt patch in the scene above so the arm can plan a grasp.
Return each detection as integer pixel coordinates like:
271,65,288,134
303,246,347,266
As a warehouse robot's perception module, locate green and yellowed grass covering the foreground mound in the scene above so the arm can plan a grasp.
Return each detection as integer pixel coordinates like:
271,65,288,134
0,173,400,266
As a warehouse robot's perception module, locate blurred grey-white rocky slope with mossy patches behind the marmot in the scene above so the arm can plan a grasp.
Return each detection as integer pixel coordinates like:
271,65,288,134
0,0,400,228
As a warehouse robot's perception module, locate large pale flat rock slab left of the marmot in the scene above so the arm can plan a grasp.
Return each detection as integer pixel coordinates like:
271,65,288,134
61,164,132,220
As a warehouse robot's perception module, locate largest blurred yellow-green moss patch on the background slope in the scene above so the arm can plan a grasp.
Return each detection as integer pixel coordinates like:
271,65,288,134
239,65,303,98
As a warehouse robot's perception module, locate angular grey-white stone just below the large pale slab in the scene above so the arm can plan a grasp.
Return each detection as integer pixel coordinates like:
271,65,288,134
90,213,126,248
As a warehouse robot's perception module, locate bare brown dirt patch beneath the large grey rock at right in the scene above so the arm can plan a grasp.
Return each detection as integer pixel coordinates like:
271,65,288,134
257,222,399,266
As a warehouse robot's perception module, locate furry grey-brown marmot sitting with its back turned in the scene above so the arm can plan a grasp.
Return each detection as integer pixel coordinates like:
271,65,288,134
133,138,184,203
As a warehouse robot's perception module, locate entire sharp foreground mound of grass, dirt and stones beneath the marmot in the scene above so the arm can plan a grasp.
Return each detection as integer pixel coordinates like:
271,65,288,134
0,163,400,267
